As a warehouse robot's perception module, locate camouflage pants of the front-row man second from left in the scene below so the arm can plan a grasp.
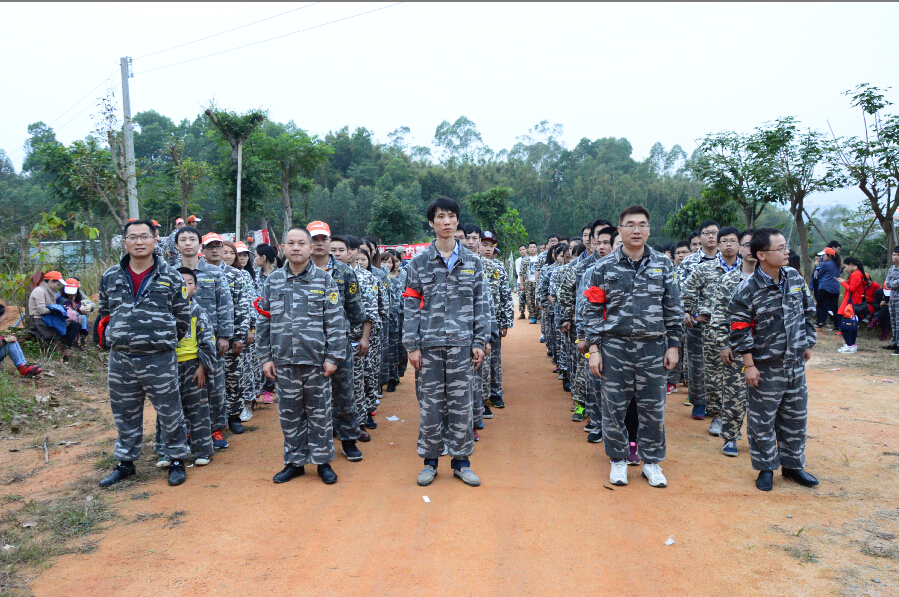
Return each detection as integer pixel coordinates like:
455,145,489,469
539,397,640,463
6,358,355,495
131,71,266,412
275,365,334,466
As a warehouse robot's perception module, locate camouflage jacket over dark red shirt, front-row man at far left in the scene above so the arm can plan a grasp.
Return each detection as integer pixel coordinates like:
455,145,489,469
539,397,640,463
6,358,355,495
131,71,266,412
100,254,190,354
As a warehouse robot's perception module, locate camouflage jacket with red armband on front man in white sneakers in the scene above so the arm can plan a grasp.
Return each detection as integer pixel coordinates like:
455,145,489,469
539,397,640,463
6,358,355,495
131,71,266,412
583,246,684,348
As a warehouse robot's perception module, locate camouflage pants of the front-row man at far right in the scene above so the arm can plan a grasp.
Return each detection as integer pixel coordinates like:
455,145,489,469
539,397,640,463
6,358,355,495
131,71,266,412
746,359,808,471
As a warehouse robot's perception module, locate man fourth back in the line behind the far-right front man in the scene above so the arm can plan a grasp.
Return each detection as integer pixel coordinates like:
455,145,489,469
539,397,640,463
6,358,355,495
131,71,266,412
677,220,719,421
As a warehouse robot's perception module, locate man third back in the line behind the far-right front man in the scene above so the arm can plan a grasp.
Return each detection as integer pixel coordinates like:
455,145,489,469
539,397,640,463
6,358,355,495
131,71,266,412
683,226,741,436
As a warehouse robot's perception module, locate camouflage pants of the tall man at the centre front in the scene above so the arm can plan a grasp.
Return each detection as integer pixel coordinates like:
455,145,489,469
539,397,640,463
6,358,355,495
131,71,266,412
415,346,474,459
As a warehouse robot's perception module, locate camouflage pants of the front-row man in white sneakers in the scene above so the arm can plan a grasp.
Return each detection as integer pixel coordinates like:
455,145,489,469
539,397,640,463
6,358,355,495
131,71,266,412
602,336,668,464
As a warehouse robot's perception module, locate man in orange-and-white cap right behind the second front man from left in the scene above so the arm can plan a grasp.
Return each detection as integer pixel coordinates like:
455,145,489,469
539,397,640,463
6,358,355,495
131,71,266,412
307,220,371,462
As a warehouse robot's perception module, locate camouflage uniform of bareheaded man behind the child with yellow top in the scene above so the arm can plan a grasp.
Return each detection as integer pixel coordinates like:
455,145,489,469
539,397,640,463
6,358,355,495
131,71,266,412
193,258,235,431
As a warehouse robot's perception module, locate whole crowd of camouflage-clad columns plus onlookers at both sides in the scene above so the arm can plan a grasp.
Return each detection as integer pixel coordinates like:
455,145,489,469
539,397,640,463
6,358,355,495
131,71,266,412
15,197,899,491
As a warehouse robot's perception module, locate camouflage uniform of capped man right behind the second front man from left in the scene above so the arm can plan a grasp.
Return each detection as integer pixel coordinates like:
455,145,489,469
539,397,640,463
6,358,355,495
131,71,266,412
325,257,364,441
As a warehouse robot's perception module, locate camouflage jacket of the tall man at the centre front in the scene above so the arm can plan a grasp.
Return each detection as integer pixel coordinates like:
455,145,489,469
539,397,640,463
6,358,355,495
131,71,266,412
403,241,490,352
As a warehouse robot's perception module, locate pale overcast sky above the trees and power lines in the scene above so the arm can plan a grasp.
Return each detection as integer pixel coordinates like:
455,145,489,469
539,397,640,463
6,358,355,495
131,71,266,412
0,2,899,207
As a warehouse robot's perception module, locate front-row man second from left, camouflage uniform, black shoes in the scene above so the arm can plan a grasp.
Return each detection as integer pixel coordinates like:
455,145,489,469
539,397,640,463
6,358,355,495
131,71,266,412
258,226,347,485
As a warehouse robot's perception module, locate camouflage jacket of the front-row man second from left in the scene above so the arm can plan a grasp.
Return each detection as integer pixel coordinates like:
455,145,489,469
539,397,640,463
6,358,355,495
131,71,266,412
256,259,347,366
